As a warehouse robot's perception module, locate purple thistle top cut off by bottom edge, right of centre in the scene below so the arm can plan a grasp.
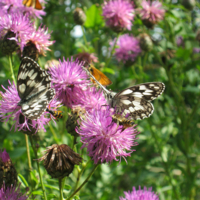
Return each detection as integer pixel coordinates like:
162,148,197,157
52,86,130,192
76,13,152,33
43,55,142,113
119,186,159,200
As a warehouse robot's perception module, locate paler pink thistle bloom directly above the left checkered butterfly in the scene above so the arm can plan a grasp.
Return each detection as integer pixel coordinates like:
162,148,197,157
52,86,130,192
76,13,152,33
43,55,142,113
24,26,55,55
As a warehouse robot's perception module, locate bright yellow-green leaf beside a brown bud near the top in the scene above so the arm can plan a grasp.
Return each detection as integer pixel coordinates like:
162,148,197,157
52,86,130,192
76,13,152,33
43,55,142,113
84,5,104,28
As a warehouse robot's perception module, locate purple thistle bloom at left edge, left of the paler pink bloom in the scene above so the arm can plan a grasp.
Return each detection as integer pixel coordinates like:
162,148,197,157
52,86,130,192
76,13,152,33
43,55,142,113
0,12,33,50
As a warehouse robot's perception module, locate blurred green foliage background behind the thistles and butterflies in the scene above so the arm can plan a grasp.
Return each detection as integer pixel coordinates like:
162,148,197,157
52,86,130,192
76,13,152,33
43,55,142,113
0,0,200,200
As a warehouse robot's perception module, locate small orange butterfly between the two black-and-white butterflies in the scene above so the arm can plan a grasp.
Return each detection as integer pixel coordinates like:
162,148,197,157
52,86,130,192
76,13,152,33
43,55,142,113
88,64,112,87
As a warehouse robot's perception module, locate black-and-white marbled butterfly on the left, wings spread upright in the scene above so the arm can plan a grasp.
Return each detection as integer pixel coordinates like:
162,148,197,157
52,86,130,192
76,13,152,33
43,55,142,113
17,57,55,120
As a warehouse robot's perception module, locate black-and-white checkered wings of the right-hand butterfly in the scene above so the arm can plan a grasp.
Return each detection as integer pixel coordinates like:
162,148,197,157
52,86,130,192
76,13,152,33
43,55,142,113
111,82,165,120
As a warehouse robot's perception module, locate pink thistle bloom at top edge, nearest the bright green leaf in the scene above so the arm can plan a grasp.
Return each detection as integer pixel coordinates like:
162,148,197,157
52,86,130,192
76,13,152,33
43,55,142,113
102,0,134,32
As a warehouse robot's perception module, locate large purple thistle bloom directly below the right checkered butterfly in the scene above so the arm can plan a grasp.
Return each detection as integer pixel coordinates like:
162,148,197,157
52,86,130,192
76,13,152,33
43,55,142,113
76,106,138,164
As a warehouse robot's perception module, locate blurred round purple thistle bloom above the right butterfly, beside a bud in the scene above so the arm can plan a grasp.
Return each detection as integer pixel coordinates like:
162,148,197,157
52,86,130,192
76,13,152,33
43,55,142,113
112,34,141,63
